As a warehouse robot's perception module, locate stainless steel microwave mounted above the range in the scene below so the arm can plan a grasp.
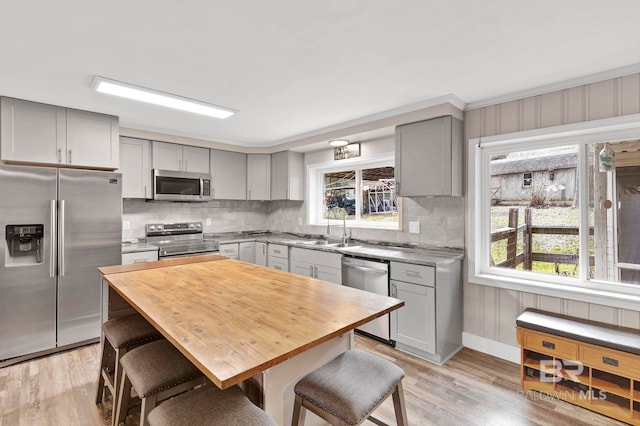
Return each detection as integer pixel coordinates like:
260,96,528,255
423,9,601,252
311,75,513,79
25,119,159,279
153,169,212,201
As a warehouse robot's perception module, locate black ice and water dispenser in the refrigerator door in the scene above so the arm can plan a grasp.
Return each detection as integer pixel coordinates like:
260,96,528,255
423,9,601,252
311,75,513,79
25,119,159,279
5,224,44,266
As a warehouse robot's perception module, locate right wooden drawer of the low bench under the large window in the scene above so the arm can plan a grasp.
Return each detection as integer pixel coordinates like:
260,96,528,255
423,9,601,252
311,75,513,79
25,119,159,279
580,343,640,380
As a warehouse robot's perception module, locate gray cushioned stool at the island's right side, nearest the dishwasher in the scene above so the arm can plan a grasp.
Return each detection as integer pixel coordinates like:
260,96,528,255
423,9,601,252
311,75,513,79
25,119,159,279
291,350,407,426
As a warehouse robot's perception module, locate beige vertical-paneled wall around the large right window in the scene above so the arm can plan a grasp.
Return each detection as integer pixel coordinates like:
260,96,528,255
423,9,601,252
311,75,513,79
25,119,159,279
464,74,640,355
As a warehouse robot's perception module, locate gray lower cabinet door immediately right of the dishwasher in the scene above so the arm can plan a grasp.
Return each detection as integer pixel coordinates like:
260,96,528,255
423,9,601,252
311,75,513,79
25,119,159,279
391,281,436,354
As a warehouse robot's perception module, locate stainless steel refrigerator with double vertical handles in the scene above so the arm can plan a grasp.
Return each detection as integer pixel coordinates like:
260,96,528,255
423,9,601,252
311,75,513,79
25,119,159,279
0,165,122,365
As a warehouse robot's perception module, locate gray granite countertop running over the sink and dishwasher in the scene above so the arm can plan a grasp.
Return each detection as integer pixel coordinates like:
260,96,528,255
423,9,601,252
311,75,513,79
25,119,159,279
205,231,464,266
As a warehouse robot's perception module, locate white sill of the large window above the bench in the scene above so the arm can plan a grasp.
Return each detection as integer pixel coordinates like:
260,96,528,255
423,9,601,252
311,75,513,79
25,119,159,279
469,273,640,311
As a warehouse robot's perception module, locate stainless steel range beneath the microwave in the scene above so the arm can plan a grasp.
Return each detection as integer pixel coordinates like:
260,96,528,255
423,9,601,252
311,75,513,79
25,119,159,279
145,222,218,259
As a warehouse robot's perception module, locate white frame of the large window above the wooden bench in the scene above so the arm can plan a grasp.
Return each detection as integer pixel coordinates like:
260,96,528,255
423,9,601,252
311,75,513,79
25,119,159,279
467,114,640,310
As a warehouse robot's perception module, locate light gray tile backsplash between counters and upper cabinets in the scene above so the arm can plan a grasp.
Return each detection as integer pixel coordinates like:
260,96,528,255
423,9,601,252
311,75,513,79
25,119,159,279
122,197,464,248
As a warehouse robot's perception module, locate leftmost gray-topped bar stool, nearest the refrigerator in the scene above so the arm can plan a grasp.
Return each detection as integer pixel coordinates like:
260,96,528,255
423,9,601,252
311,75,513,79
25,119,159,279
96,314,162,422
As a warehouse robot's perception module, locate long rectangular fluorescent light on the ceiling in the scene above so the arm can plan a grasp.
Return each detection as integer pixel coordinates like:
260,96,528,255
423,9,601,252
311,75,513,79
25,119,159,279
91,75,236,118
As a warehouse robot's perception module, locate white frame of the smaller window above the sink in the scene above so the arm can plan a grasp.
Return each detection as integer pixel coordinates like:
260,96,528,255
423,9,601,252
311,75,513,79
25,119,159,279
306,153,402,231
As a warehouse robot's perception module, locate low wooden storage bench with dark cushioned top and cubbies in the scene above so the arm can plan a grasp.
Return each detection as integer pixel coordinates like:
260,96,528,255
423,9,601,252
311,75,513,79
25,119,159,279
517,310,640,425
